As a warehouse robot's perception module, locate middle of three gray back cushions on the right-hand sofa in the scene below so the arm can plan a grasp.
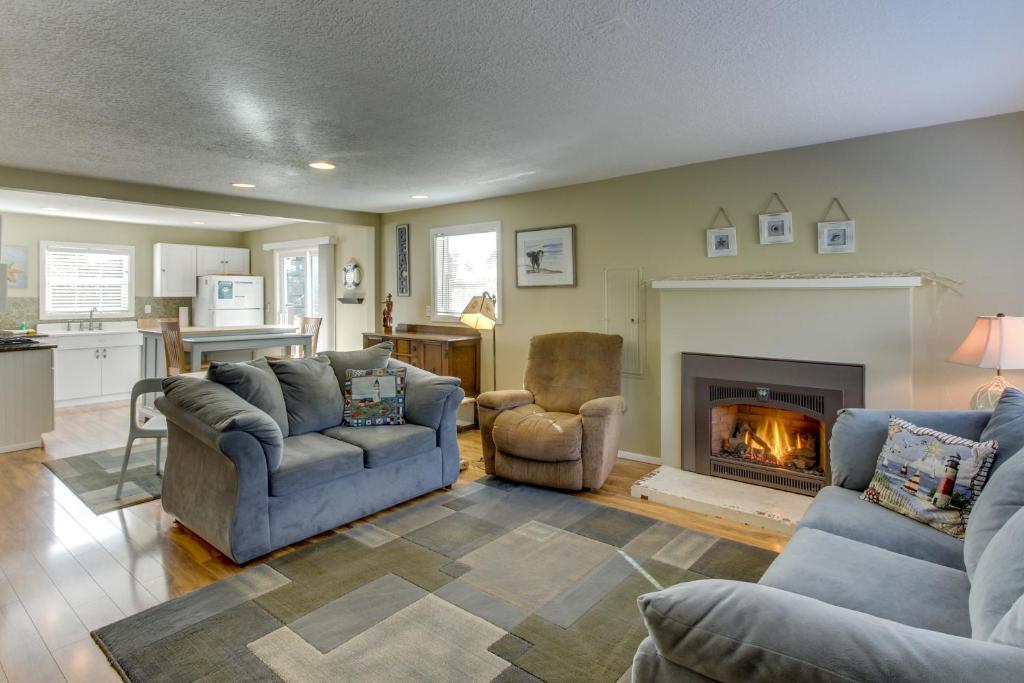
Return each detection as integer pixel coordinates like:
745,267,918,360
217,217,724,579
964,452,1024,581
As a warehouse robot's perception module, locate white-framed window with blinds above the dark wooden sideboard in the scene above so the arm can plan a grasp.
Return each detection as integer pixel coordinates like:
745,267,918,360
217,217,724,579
430,222,502,319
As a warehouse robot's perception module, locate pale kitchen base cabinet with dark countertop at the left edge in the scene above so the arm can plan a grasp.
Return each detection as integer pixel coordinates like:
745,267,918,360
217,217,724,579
0,343,56,453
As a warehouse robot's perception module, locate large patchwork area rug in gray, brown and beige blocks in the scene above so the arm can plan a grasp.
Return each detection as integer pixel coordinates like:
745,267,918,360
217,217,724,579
92,477,775,682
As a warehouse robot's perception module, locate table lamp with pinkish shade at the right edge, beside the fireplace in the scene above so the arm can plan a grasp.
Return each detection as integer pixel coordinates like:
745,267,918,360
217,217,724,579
949,313,1024,411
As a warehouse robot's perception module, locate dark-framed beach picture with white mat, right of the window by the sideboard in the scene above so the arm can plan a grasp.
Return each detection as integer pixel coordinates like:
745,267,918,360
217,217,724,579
515,225,575,287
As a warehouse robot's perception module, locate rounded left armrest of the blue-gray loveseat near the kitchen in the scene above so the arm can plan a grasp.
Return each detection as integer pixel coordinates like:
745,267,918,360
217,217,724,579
157,376,285,472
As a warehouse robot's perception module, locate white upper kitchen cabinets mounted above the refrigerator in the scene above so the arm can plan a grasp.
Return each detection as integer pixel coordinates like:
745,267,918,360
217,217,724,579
153,244,250,297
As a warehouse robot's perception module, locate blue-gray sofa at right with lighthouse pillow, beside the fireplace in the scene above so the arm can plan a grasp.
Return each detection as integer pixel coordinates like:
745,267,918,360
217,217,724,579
633,409,1024,681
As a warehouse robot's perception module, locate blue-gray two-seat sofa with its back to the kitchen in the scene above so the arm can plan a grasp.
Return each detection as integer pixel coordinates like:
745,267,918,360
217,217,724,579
157,359,465,564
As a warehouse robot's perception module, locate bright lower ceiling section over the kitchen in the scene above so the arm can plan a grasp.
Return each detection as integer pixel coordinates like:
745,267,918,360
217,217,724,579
0,188,303,232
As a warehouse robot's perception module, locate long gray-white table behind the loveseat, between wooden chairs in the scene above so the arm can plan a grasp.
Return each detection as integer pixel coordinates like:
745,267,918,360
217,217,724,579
138,321,313,377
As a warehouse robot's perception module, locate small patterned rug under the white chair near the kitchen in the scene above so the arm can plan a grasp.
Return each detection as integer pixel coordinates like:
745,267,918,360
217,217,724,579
43,439,160,515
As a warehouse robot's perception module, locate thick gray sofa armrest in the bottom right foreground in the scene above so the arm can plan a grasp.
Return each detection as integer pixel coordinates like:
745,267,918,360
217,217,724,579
637,580,1024,683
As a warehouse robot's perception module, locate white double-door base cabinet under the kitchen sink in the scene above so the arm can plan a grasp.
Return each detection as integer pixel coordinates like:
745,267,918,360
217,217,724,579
51,332,142,405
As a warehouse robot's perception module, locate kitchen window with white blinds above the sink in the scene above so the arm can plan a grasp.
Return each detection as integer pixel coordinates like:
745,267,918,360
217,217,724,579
39,242,135,318
